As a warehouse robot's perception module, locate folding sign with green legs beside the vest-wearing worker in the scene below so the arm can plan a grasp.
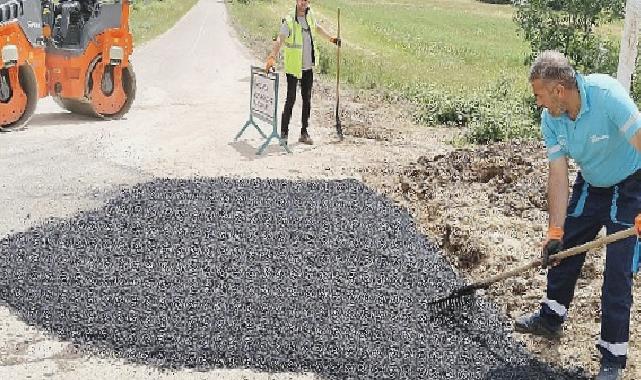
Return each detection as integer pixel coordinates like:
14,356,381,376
234,66,291,155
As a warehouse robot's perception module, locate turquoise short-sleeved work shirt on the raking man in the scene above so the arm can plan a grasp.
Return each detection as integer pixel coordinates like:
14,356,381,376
541,74,641,187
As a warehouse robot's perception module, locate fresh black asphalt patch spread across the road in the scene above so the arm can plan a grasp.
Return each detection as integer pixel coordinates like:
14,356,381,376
0,178,580,380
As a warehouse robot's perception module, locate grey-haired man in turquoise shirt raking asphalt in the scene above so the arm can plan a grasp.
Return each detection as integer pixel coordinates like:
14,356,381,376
515,51,641,380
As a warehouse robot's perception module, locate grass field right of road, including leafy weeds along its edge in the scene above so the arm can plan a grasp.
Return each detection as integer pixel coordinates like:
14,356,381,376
228,0,617,143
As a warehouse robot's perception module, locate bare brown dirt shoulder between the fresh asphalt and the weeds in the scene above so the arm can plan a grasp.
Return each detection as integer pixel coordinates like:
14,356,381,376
228,4,641,379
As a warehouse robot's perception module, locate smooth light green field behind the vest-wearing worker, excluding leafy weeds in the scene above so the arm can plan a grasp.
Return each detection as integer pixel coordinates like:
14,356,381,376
229,0,528,93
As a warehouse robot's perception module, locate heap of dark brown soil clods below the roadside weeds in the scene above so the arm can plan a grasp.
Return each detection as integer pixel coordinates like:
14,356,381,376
401,141,547,217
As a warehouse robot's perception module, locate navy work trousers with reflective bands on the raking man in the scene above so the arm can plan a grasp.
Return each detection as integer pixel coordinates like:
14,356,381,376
541,172,641,367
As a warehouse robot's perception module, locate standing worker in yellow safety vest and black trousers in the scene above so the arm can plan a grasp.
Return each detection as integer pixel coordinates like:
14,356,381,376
265,0,341,145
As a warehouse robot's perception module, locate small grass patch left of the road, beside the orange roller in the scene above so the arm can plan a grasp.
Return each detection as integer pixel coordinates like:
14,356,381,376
129,0,198,45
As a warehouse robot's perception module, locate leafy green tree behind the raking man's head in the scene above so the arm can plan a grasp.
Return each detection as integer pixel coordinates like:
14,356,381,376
514,0,625,74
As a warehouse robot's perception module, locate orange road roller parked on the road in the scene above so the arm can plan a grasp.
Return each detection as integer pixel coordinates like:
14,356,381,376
0,0,136,130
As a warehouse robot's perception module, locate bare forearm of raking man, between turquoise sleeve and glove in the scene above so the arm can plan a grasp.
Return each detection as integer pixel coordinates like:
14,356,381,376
548,157,570,228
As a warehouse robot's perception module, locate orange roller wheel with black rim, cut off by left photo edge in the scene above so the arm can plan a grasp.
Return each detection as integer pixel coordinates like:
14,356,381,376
0,65,38,131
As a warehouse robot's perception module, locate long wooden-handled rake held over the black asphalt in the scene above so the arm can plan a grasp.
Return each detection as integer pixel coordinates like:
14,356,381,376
428,227,636,311
